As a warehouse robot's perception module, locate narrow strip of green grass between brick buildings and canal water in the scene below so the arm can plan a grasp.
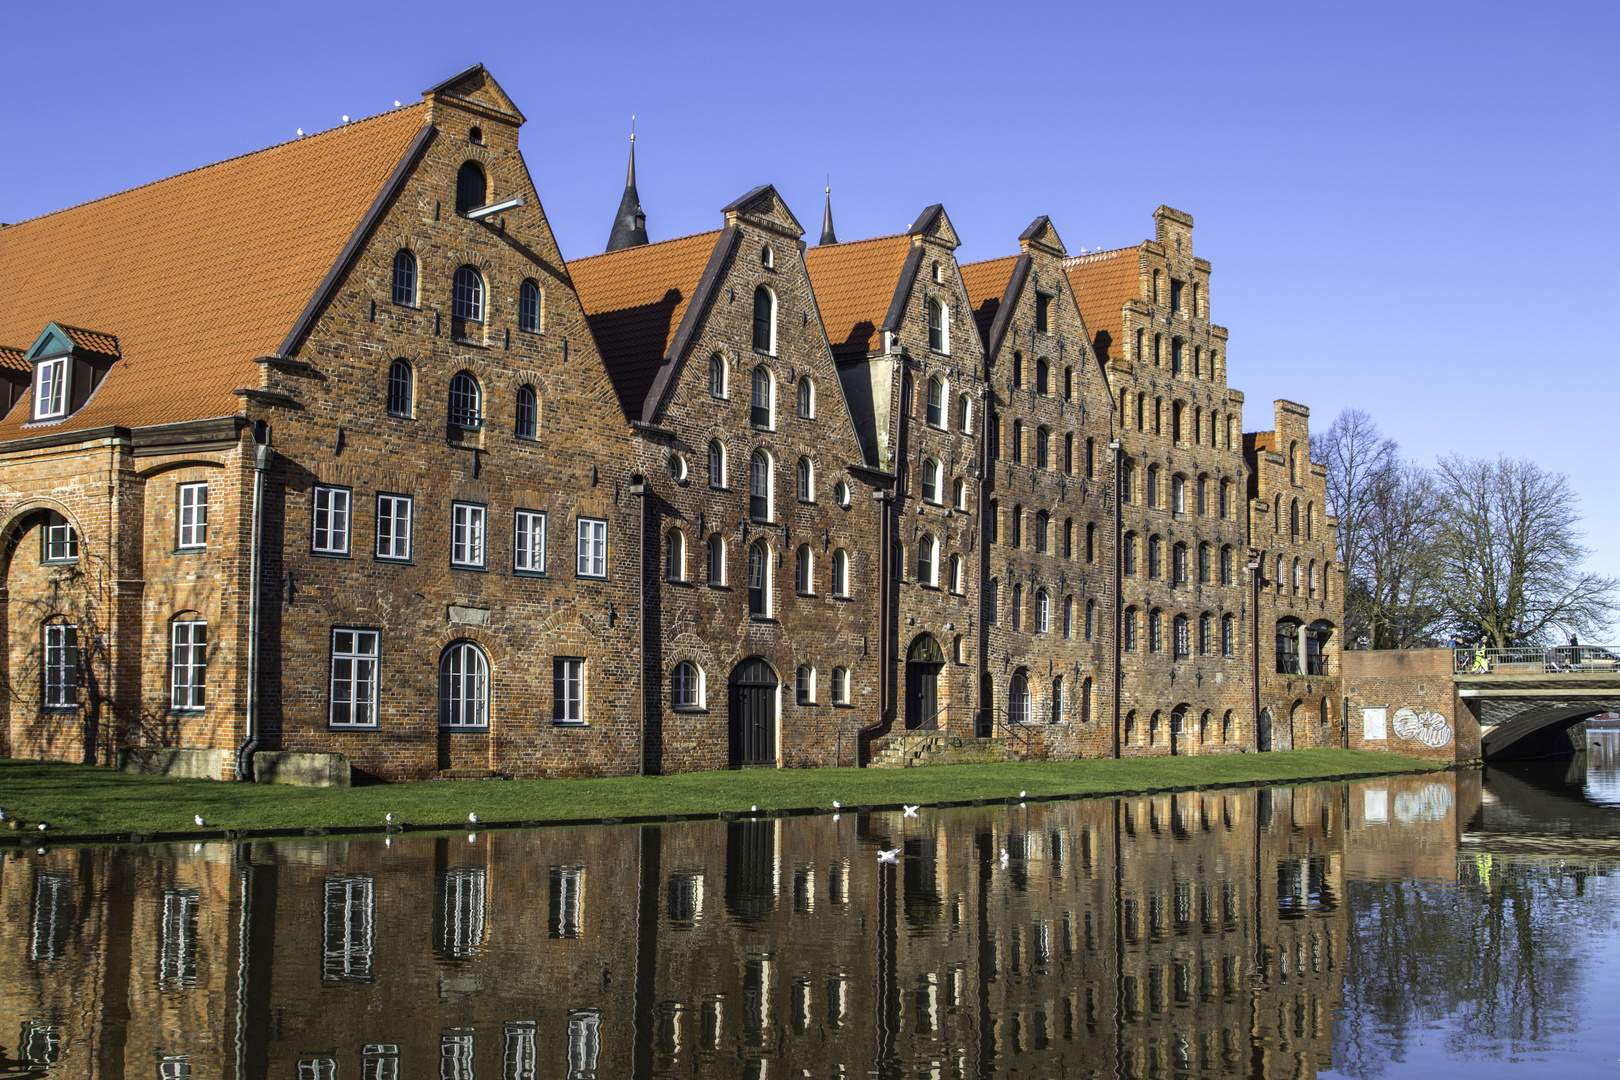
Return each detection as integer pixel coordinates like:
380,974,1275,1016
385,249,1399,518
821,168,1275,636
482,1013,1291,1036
0,750,1435,840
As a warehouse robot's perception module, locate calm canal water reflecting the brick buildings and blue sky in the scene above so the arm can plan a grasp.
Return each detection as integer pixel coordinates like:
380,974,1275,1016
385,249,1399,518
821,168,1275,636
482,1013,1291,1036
0,756,1620,1080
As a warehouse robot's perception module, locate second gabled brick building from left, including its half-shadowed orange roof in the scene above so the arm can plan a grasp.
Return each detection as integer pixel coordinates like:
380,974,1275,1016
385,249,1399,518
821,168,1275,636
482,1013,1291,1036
569,185,883,771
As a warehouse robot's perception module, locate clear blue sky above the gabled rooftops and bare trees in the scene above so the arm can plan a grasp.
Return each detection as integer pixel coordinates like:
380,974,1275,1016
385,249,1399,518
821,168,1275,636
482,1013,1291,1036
9,0,1620,608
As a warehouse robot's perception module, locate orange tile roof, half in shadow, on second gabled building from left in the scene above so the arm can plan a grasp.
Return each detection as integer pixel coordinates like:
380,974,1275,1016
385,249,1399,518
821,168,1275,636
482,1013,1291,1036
569,230,719,419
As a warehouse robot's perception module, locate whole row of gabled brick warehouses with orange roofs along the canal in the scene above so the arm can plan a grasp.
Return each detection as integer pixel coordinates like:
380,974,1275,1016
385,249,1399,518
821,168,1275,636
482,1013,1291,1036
0,65,1343,779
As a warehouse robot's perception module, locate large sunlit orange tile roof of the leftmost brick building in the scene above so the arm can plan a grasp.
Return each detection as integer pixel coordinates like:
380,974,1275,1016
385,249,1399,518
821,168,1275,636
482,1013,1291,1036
0,105,426,440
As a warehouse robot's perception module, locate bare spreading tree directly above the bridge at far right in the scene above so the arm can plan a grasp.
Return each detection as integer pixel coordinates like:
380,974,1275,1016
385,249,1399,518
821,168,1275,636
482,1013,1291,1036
1435,457,1620,648
